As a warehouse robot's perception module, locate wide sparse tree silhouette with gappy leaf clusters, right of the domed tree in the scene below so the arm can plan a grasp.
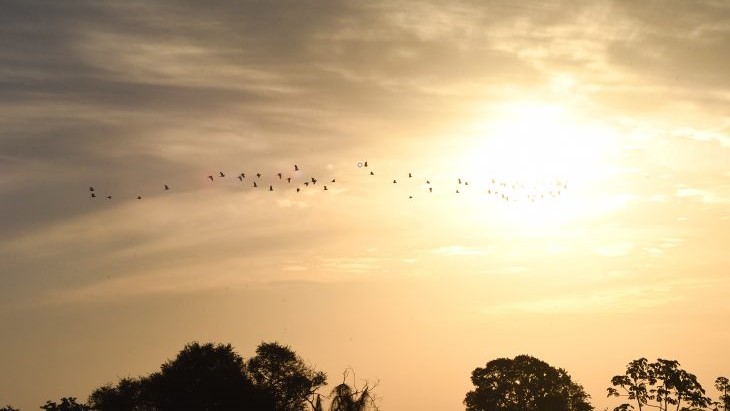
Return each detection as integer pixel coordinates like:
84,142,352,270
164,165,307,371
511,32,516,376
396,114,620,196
608,358,711,411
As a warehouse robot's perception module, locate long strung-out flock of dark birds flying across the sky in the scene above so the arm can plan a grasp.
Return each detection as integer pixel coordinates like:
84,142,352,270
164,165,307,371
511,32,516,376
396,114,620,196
84,161,568,202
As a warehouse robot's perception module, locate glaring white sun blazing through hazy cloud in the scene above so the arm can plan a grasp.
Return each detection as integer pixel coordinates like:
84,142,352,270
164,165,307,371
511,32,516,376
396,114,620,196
464,102,612,227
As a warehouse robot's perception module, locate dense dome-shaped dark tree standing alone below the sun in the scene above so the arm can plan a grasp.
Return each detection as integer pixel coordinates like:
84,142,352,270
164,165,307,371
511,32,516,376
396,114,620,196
464,355,593,411
